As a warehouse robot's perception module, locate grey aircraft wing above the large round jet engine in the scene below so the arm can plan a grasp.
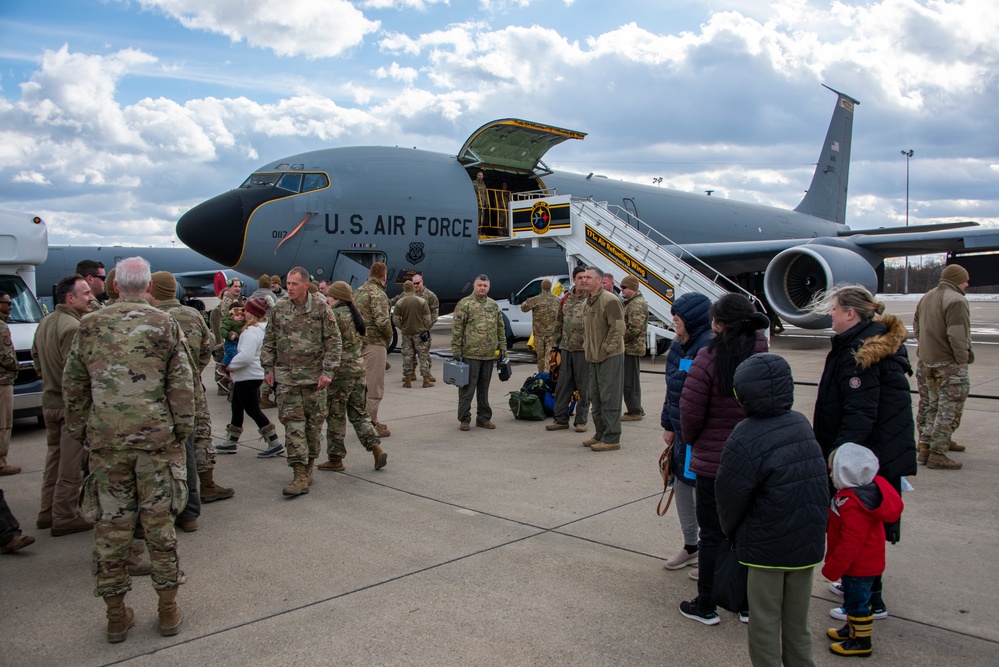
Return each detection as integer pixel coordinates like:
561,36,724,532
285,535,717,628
683,228,999,275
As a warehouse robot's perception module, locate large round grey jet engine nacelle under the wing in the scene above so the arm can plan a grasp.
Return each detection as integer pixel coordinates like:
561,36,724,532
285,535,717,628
763,244,878,329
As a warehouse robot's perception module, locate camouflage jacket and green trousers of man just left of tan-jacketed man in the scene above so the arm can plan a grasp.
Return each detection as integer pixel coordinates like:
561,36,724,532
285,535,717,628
552,288,590,426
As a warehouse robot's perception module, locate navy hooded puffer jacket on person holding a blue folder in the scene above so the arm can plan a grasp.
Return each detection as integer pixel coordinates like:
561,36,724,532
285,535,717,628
659,292,714,486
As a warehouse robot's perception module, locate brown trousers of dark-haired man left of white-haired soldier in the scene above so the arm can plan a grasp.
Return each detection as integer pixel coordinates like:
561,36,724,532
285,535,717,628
38,408,86,526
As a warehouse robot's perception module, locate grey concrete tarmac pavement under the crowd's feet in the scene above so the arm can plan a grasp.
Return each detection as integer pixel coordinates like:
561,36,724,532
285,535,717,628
0,302,999,667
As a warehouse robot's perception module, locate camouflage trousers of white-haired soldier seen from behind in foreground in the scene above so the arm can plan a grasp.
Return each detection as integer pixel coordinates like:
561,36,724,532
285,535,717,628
83,447,187,597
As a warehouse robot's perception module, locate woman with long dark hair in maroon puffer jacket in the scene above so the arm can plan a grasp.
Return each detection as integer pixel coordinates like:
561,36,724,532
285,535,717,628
680,294,770,625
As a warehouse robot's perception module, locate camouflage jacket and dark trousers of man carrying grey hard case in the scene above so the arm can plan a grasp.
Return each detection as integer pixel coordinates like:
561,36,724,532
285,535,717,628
451,294,506,424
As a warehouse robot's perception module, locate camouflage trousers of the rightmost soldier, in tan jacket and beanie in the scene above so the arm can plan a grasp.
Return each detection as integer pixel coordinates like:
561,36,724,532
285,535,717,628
916,362,971,454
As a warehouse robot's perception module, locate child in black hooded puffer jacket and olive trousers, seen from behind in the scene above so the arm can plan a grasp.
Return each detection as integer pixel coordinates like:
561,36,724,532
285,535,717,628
715,354,829,665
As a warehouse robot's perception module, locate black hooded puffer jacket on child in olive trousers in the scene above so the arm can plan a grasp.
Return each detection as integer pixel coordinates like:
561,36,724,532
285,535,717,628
715,354,829,568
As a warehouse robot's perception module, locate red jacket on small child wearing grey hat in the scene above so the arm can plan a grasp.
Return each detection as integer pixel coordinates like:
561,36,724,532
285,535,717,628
822,475,903,581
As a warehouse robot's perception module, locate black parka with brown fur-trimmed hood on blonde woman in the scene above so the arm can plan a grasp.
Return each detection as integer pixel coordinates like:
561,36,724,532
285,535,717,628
812,315,916,489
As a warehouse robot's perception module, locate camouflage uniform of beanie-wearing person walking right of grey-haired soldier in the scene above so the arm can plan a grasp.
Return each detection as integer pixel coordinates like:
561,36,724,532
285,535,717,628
326,303,381,461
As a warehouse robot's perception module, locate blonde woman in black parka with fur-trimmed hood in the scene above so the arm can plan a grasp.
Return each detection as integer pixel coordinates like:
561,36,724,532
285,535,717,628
812,285,916,620
